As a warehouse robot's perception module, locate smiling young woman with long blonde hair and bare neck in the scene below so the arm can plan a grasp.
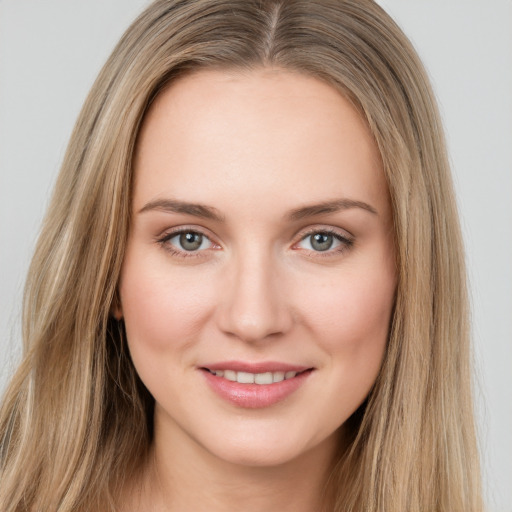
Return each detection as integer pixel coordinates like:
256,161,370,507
0,0,481,512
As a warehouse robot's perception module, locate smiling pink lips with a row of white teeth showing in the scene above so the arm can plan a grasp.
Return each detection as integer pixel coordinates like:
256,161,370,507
200,362,313,409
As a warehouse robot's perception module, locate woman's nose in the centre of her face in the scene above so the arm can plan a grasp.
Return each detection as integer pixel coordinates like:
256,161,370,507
218,249,293,343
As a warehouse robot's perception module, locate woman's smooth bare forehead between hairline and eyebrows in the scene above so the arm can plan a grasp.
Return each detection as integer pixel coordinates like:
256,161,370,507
134,69,387,218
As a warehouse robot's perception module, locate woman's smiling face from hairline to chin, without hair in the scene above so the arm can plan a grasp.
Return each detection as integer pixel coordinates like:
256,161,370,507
116,69,396,465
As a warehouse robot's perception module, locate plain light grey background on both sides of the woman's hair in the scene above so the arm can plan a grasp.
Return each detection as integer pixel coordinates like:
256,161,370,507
0,0,512,512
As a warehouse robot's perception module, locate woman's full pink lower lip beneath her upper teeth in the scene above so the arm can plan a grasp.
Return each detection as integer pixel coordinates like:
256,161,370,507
201,370,312,409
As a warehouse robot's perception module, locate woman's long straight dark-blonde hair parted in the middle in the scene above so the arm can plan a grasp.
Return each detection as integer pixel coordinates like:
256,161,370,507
0,0,482,512
